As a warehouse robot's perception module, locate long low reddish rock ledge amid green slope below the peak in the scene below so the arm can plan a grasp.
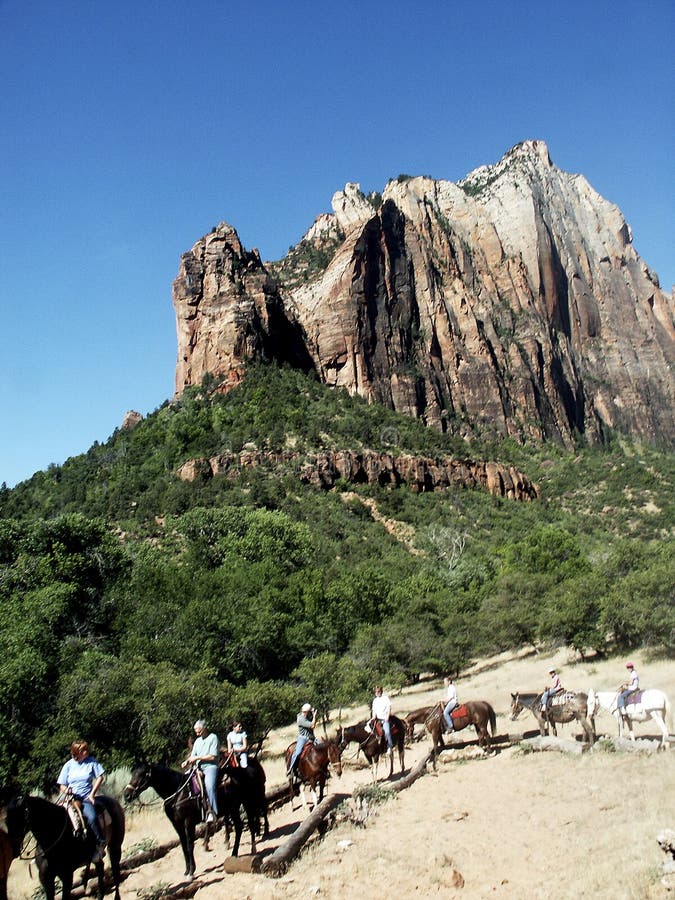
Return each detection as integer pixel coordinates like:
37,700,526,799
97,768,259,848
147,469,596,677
177,450,539,500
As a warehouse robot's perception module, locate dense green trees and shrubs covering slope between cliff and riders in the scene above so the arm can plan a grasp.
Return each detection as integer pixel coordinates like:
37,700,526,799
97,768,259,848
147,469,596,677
0,368,675,784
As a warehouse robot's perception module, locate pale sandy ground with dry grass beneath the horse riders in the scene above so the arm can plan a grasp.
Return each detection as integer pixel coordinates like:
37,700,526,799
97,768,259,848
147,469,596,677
9,651,675,900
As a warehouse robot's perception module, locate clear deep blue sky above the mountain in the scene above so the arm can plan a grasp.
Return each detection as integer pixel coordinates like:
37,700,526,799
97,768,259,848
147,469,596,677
0,0,675,486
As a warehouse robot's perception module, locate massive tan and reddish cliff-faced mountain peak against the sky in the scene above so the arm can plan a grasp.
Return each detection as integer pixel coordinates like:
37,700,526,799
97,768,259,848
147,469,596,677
174,141,675,446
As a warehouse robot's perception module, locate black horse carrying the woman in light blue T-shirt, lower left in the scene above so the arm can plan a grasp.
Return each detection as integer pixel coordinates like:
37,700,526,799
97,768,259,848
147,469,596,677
5,794,125,900
